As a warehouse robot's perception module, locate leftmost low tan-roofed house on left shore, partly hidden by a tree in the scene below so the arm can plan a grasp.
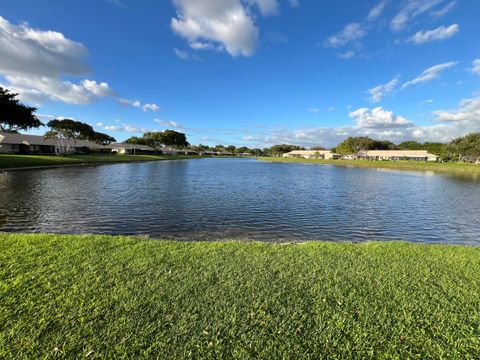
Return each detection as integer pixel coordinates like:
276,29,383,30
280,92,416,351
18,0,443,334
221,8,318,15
0,133,110,155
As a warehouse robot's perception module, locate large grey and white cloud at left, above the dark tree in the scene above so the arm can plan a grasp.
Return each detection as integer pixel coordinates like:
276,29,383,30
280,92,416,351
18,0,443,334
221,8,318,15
0,17,114,104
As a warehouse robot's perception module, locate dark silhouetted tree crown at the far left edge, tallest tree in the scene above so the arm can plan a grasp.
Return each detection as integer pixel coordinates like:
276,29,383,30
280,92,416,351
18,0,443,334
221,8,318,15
0,87,43,133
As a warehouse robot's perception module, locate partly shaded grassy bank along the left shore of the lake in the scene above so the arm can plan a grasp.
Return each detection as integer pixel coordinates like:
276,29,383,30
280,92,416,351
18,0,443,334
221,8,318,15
0,155,198,169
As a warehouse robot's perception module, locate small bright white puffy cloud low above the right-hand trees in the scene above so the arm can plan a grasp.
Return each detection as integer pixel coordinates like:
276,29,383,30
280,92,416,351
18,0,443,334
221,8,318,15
348,107,413,129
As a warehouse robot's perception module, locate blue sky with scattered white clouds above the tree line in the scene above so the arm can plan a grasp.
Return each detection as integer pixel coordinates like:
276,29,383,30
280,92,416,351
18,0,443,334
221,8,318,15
0,0,480,147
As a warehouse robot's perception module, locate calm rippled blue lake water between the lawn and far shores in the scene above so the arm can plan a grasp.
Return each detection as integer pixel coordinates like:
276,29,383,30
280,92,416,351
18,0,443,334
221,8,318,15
0,159,480,245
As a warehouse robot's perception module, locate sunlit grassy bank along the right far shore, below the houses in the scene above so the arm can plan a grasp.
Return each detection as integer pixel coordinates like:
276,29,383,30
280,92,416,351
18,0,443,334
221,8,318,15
259,157,480,174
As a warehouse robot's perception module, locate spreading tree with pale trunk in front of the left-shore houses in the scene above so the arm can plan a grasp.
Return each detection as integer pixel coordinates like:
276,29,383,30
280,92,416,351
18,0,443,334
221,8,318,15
45,119,95,154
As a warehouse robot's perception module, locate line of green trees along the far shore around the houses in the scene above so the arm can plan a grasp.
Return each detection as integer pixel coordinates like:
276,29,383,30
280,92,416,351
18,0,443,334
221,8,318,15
0,87,480,162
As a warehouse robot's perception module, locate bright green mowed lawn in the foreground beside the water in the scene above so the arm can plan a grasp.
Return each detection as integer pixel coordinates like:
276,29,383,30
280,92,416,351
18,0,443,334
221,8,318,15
0,234,480,359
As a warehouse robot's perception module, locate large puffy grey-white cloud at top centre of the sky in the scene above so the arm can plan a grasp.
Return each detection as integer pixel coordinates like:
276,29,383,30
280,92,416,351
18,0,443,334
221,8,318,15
171,0,266,56
